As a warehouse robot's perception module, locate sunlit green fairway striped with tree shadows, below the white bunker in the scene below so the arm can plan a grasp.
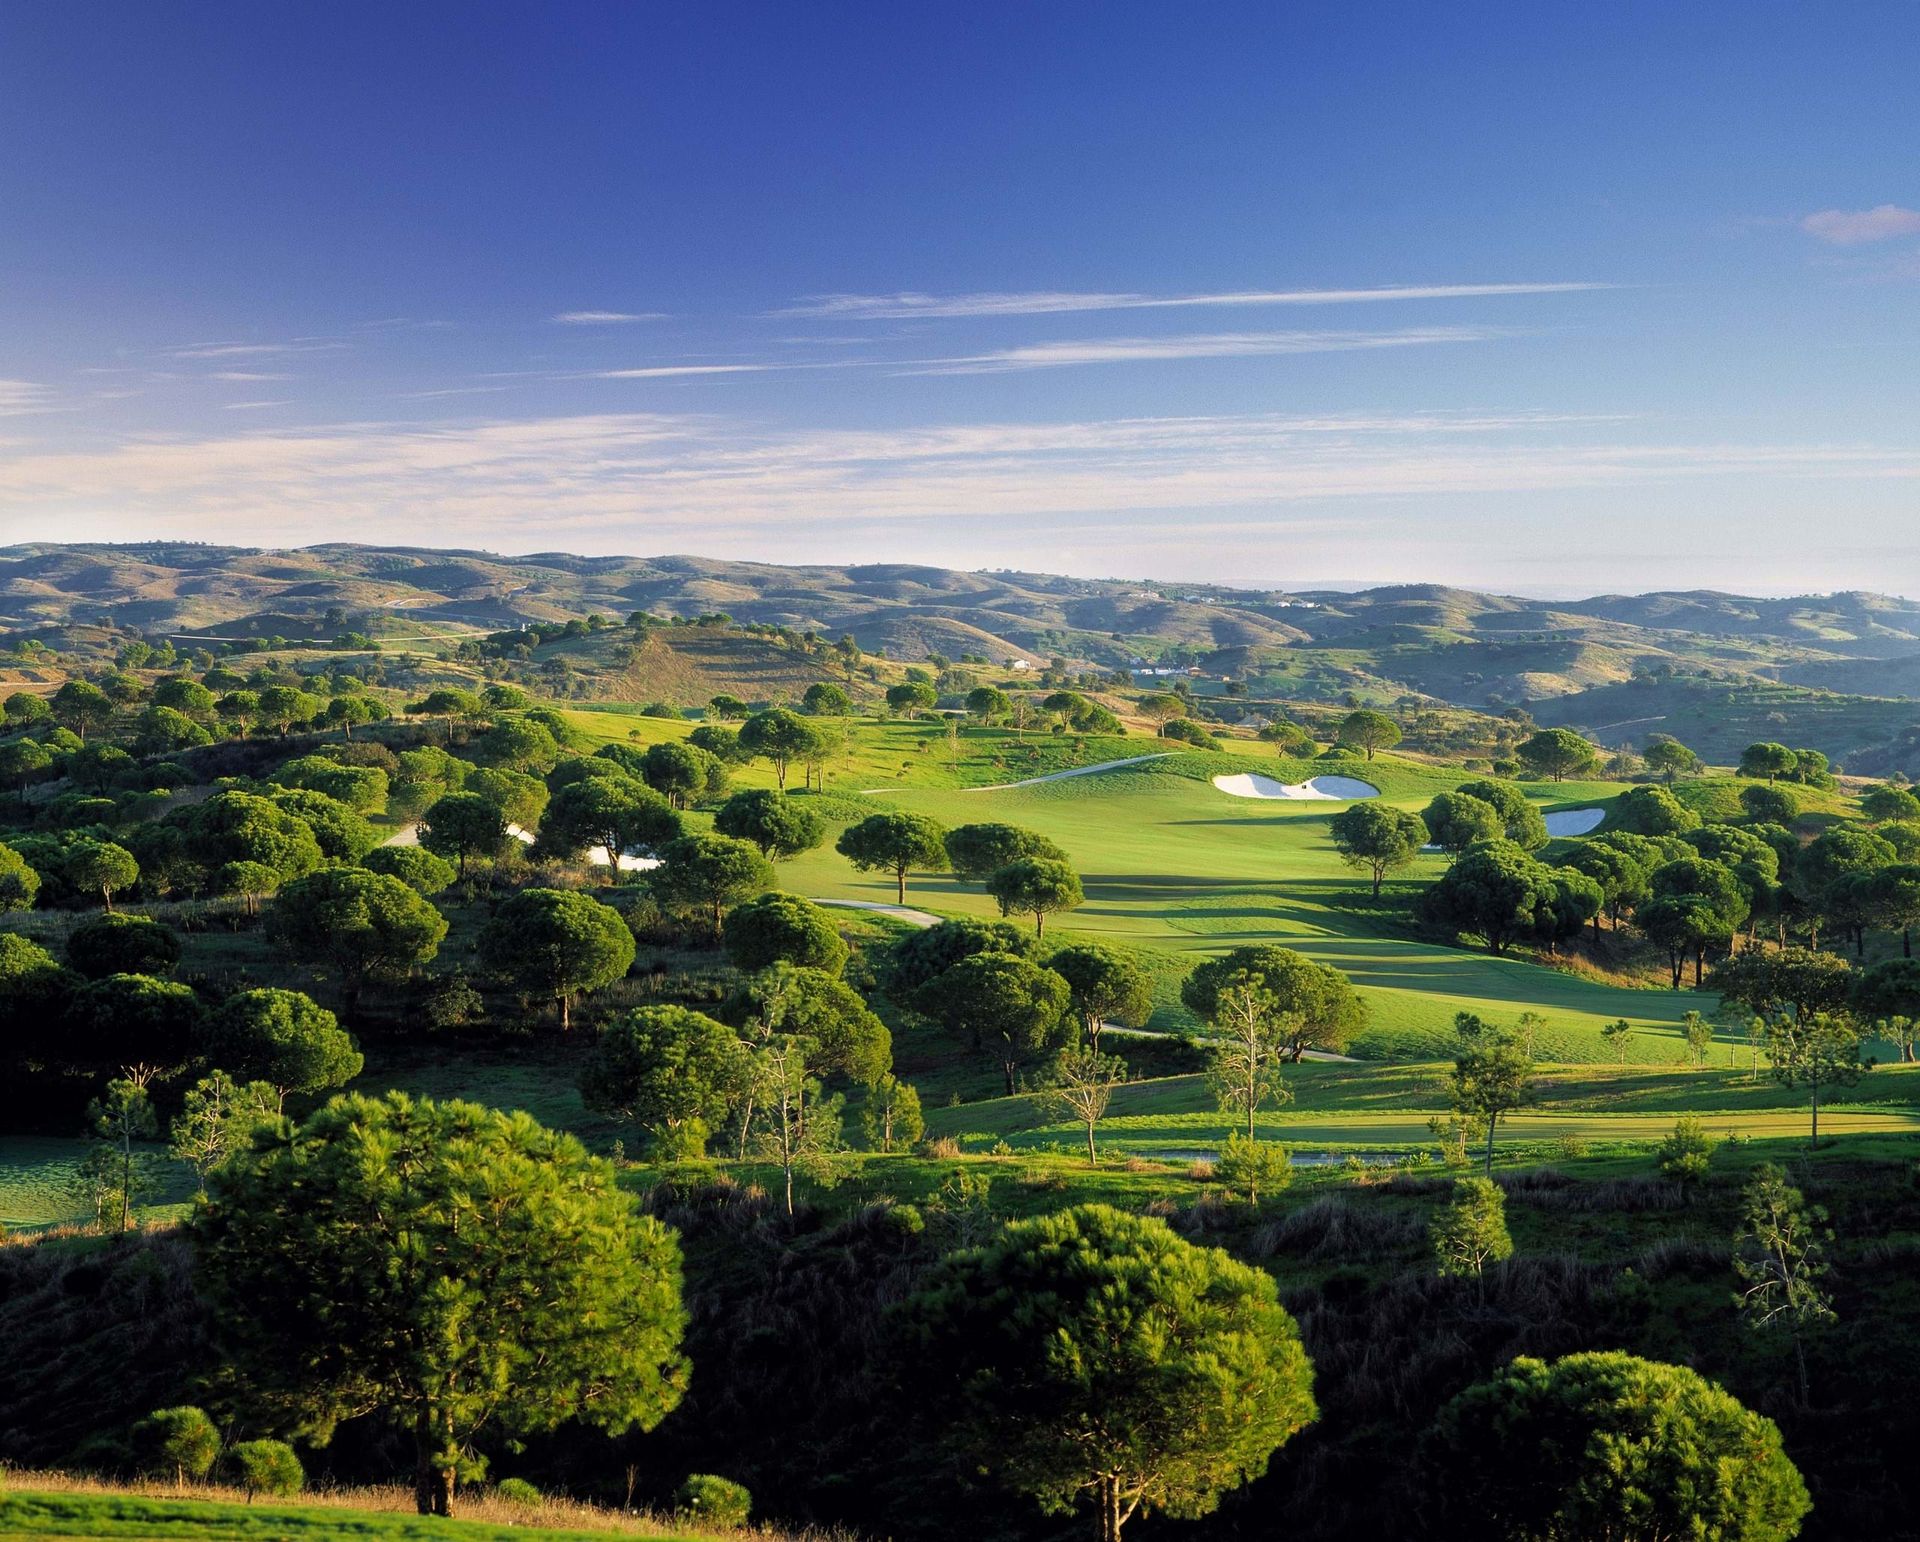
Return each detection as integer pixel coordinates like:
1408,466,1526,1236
748,751,1713,1064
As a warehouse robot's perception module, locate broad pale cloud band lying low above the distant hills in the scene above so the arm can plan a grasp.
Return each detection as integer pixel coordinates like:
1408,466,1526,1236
0,403,1920,555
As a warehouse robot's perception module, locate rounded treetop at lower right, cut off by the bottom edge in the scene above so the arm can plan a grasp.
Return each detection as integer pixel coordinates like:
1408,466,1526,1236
1417,1352,1812,1542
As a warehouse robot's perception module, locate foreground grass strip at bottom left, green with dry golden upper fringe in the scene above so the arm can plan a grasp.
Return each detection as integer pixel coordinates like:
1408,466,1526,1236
0,1473,749,1542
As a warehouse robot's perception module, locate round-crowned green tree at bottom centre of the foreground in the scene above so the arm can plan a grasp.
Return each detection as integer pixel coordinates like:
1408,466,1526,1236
906,1204,1319,1542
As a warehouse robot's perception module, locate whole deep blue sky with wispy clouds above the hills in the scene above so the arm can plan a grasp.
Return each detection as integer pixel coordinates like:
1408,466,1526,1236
0,0,1920,597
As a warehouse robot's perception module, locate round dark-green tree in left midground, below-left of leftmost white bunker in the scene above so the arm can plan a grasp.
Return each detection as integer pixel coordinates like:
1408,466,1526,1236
269,868,447,1010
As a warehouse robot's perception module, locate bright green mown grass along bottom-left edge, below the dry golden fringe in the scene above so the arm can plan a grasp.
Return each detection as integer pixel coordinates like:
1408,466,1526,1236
0,1492,708,1542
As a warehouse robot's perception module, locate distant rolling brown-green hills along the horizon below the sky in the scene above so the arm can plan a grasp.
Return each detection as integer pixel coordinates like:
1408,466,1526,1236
11,542,1920,771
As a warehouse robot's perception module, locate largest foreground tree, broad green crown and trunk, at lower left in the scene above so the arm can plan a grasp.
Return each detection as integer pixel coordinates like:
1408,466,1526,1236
190,1093,687,1515
